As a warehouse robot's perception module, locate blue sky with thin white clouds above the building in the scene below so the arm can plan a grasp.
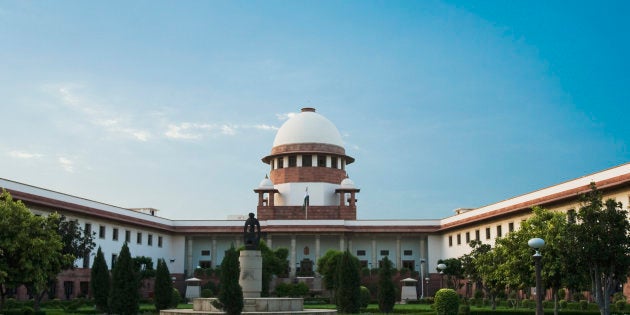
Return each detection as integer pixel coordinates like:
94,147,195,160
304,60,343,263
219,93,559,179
0,1,630,219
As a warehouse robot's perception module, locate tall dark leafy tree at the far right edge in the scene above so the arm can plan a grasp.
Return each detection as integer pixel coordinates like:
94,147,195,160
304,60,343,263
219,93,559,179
573,183,630,315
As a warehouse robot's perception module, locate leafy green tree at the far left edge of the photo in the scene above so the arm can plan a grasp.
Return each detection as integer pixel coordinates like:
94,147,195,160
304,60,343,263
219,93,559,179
0,190,73,310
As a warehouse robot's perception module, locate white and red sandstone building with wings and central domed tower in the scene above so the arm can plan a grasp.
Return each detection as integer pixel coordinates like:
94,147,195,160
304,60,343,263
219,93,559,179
0,108,630,298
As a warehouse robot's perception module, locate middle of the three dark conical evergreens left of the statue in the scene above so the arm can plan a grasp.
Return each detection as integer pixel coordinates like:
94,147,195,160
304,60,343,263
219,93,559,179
109,242,140,315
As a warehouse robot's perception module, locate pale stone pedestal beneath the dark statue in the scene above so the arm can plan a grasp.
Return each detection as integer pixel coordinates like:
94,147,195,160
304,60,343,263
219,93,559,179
238,249,262,298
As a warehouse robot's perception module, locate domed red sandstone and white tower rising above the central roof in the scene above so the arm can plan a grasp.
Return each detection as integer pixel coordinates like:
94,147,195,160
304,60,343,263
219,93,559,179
254,107,359,220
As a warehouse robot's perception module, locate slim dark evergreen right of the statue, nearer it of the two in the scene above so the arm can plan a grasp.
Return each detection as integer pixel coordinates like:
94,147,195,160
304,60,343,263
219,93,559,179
336,250,361,314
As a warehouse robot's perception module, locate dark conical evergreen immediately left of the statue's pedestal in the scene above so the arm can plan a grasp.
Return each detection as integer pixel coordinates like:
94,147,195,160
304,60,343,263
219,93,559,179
214,245,243,315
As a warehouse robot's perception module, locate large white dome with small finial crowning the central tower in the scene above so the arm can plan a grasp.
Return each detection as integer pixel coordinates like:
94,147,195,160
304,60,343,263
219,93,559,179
273,108,343,148
